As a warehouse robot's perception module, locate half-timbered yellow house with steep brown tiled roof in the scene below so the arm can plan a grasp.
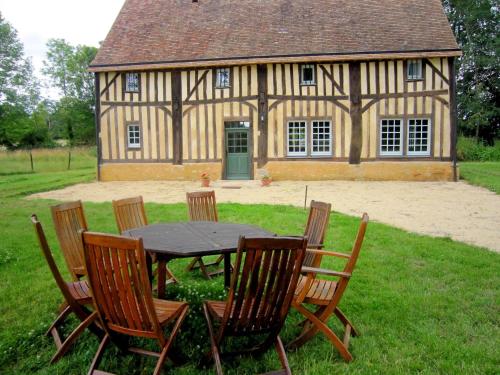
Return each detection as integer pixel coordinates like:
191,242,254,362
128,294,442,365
90,0,460,180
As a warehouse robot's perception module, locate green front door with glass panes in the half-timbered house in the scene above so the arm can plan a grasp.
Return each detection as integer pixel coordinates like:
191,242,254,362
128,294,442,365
225,121,250,180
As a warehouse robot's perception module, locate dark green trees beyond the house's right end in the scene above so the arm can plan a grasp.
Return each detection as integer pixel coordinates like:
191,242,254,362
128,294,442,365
443,0,500,143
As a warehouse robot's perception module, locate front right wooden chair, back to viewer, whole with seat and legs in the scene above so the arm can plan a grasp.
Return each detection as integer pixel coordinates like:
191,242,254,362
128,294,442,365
203,237,307,374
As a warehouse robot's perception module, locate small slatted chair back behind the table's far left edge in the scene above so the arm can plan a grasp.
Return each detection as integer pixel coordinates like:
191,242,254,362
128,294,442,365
113,196,148,233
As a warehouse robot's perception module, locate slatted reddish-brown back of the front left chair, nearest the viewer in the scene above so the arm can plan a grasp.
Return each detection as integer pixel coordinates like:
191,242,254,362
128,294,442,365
82,232,165,346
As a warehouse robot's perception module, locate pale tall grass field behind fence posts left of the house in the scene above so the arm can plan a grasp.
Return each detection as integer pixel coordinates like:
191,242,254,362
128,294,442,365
0,147,96,175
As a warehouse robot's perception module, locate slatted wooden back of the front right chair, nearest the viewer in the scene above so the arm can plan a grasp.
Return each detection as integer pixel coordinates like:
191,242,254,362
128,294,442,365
219,237,307,342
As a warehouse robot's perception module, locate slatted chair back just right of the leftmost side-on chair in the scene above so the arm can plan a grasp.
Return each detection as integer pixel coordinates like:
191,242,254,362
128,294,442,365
51,201,88,280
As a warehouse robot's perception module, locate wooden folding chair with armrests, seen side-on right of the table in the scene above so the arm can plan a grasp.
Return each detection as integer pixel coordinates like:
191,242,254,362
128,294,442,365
287,213,368,361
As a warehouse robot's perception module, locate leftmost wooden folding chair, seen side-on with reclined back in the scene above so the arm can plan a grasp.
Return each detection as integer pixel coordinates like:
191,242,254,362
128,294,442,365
31,215,102,363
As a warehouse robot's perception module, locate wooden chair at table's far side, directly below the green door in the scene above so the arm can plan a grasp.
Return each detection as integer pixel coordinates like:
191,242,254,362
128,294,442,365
186,191,224,279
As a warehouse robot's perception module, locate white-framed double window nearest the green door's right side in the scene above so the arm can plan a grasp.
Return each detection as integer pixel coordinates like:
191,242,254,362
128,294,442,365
287,120,332,156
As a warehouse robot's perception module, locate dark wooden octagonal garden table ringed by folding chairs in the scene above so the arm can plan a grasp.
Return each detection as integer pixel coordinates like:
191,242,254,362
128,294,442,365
124,221,275,298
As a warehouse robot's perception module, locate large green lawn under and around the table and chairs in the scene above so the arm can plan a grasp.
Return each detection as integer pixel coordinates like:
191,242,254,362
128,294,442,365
0,169,500,374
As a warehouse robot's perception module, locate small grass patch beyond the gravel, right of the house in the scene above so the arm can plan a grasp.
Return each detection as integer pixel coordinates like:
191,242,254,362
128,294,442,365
460,161,500,194
